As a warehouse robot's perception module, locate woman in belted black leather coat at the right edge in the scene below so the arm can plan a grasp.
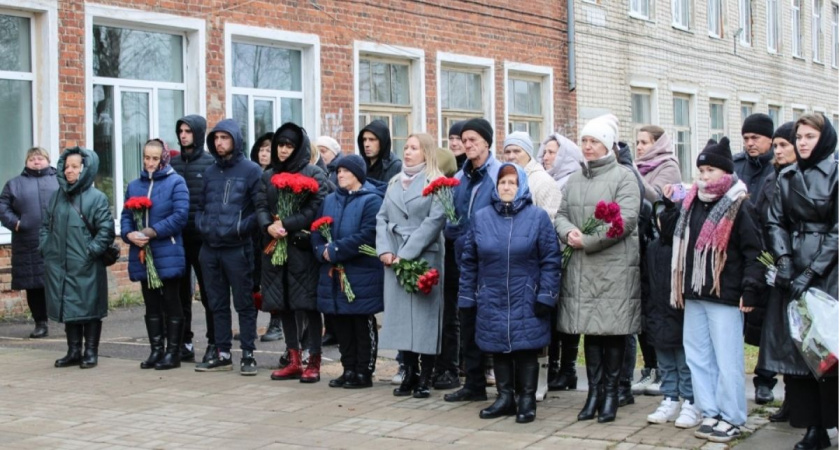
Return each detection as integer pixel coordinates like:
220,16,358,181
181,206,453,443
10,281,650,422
766,114,838,450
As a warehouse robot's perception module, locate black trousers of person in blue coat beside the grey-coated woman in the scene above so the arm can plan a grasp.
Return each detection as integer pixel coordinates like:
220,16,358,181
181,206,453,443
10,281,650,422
334,314,376,375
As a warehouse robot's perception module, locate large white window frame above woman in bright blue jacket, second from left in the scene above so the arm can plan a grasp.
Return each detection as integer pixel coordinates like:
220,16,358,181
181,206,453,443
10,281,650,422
85,4,207,231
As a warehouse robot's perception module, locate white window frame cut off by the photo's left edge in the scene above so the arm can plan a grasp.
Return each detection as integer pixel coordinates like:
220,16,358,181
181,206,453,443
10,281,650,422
0,0,61,245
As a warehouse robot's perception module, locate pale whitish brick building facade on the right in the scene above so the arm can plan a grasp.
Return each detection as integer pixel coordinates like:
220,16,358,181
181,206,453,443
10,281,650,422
573,0,840,181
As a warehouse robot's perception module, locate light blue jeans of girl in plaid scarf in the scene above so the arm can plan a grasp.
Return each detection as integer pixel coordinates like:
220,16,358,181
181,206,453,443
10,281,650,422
684,299,747,426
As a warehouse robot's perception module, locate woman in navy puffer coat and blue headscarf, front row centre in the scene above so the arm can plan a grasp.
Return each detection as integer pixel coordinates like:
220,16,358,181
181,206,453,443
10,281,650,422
458,164,561,423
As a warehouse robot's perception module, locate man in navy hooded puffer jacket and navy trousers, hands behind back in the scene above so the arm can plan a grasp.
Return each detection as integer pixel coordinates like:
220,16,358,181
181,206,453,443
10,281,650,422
195,119,265,375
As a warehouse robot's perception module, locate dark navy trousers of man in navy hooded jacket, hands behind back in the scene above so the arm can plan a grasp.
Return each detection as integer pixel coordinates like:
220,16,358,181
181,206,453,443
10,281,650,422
198,241,256,352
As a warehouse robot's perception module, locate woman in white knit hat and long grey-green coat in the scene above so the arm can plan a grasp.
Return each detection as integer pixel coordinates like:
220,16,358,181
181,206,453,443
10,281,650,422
554,118,641,422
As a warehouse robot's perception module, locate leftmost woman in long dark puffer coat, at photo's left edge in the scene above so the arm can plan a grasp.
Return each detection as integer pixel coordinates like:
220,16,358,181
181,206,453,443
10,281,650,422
0,147,58,339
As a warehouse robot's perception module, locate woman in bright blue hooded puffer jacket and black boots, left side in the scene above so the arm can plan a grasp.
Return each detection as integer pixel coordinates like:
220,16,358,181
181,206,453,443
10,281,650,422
120,139,190,370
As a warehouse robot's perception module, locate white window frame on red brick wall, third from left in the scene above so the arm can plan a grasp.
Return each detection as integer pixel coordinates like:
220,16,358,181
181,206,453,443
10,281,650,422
225,23,321,148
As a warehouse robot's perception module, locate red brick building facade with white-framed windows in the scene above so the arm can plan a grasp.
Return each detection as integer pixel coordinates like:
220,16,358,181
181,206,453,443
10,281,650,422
0,0,577,315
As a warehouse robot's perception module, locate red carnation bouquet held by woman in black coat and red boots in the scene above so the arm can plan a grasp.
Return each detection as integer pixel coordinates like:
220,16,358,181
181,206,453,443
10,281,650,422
263,172,318,266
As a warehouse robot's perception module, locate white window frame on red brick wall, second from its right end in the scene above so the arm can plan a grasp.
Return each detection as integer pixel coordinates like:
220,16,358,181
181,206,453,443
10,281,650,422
435,52,496,147
